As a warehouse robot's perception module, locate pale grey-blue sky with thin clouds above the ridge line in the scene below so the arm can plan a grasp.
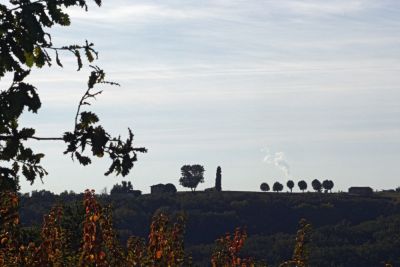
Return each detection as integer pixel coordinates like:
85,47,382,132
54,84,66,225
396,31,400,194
0,0,400,193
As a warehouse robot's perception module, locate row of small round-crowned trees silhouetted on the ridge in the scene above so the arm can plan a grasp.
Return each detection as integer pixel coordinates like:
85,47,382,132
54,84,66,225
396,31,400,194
260,179,334,193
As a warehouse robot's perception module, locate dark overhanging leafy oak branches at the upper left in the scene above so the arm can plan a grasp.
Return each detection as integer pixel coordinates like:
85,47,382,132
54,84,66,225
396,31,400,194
0,0,147,191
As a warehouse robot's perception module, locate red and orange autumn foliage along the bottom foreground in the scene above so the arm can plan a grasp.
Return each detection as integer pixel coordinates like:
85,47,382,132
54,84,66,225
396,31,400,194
0,190,311,267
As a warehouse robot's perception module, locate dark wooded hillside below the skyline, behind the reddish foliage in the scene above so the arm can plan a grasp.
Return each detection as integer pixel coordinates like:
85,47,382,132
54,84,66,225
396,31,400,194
21,191,400,266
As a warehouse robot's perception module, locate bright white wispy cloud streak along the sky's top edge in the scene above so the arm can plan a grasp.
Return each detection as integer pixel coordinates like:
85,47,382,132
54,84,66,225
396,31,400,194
70,0,373,24
